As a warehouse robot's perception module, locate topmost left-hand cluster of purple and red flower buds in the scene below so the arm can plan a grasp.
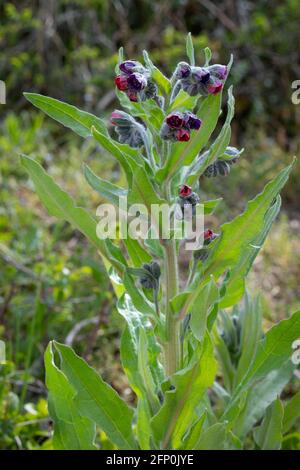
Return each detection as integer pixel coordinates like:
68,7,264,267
115,60,157,101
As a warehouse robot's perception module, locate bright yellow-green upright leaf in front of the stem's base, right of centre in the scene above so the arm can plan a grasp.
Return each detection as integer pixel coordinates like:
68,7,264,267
152,335,217,449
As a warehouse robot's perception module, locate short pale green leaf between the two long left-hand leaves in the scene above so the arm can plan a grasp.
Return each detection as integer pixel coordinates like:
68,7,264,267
83,165,127,207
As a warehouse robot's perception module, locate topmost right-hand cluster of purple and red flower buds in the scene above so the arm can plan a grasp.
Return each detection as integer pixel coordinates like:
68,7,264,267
175,62,228,96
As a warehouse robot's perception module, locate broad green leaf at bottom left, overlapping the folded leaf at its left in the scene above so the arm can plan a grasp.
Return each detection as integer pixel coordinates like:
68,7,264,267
53,342,136,450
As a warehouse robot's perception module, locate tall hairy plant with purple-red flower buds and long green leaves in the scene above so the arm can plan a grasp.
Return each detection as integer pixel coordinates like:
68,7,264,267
22,35,300,450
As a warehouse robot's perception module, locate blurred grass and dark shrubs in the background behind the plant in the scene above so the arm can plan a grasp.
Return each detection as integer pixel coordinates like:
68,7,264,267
0,0,300,449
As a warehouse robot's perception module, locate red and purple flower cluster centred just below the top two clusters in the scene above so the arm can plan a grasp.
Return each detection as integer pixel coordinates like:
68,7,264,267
160,111,202,142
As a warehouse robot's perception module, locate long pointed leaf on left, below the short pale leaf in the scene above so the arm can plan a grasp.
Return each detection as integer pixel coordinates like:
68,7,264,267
21,155,123,270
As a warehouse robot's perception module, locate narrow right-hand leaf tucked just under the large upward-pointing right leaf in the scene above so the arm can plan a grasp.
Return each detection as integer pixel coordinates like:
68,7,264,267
220,196,281,308
